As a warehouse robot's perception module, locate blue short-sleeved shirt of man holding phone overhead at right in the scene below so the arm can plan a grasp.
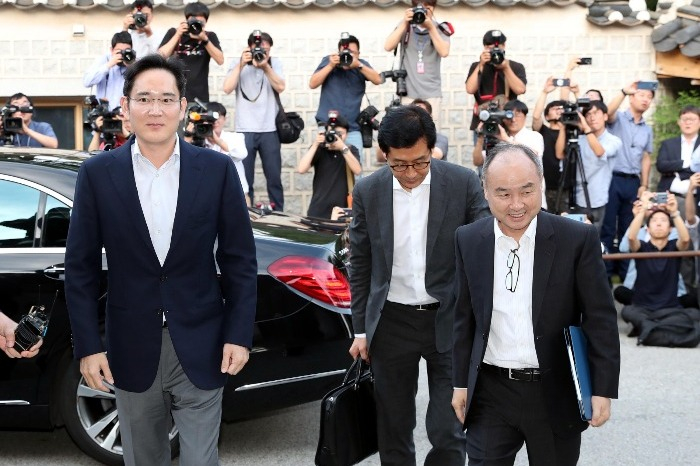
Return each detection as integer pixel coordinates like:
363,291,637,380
608,110,654,175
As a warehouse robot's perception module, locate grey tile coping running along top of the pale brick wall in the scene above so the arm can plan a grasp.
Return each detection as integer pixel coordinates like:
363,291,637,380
0,0,668,26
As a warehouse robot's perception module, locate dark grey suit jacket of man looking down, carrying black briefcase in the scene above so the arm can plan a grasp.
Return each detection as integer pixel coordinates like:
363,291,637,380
350,159,489,353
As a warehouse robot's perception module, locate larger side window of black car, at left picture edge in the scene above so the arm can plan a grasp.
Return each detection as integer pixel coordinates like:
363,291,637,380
0,180,40,248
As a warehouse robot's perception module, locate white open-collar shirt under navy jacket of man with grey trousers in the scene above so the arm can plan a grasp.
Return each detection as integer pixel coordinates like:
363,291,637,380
131,137,180,265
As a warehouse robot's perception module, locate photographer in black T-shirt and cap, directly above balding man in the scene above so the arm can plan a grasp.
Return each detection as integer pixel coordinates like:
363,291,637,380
465,29,527,137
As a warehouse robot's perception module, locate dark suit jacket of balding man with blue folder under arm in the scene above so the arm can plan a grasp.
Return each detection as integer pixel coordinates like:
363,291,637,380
452,212,620,434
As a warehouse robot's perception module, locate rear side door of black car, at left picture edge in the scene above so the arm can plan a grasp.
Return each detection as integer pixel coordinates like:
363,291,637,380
0,174,70,412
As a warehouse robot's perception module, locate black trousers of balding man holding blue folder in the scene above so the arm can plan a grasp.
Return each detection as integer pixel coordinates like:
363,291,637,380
467,369,581,466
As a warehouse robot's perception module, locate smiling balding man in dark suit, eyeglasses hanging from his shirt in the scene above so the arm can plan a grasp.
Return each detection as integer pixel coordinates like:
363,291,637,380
452,144,620,466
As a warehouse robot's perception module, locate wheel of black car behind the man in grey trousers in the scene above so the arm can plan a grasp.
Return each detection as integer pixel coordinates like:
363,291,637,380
59,354,180,465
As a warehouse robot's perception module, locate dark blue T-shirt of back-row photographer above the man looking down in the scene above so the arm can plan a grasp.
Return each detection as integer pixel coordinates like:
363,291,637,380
314,57,372,131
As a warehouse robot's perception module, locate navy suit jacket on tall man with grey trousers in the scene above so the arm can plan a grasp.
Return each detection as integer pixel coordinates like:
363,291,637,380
66,140,257,392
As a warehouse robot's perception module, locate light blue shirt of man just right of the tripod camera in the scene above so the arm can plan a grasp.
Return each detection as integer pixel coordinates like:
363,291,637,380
576,130,622,209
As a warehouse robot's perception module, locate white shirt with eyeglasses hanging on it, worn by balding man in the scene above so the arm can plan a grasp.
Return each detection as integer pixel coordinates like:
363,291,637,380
484,217,539,369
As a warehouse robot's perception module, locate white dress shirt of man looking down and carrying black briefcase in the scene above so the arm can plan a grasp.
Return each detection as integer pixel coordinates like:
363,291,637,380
387,172,436,305
